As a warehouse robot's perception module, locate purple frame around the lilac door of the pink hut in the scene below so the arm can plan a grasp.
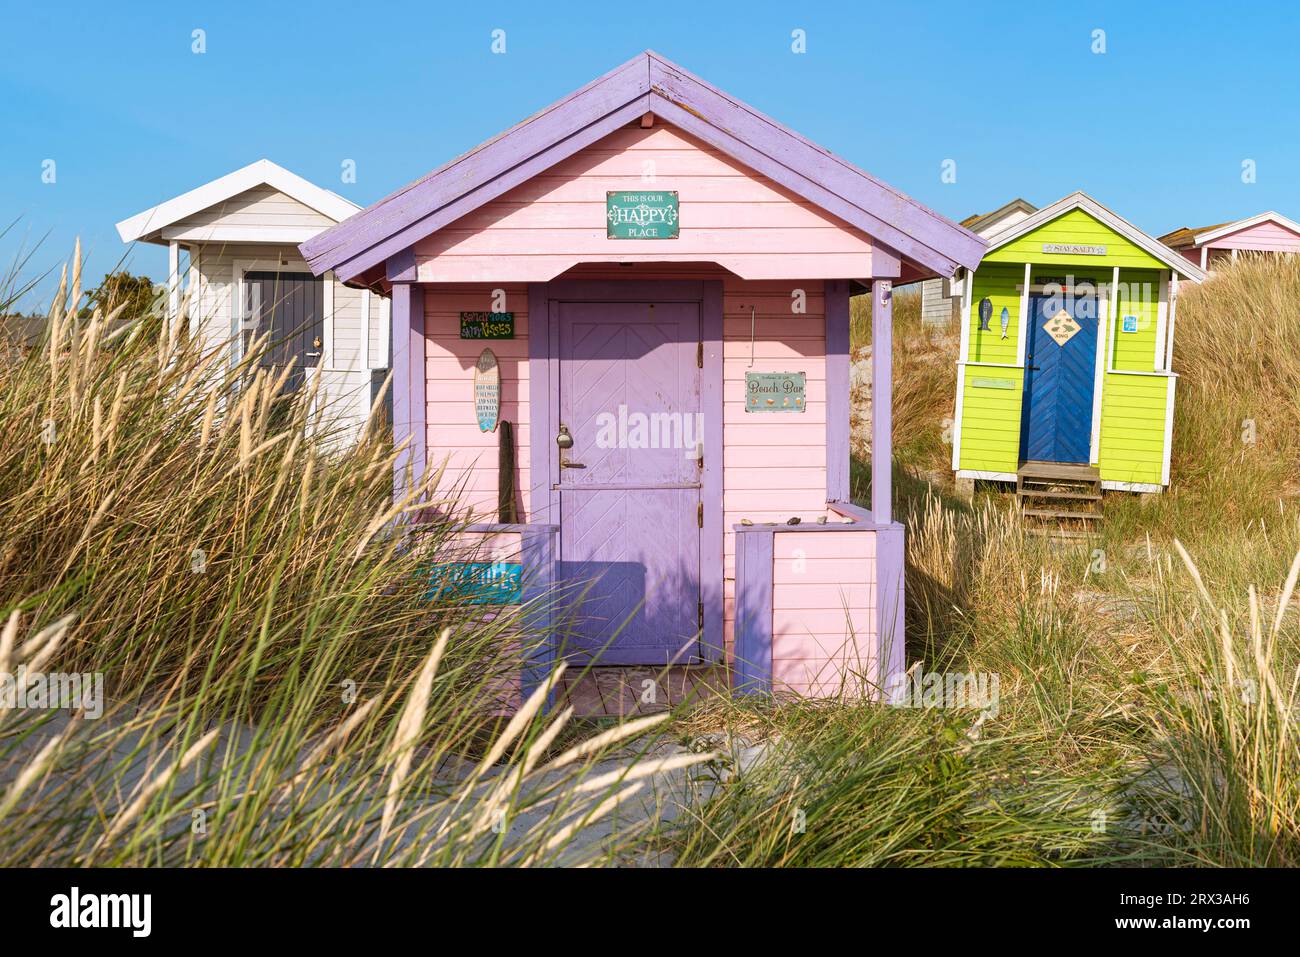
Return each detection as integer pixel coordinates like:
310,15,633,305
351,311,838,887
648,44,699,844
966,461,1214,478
528,280,723,663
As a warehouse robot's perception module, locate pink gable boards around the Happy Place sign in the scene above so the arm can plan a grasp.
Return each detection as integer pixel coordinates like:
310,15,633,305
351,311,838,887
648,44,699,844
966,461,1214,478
415,117,871,281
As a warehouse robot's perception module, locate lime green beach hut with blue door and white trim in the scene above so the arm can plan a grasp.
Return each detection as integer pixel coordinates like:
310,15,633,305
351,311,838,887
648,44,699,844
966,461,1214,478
953,192,1205,504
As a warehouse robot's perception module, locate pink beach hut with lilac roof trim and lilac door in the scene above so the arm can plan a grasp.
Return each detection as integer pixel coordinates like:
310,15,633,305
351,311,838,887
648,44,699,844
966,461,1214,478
300,52,984,696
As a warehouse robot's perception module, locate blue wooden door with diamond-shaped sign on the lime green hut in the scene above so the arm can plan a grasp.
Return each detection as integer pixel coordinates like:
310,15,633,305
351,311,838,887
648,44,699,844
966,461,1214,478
1021,295,1097,464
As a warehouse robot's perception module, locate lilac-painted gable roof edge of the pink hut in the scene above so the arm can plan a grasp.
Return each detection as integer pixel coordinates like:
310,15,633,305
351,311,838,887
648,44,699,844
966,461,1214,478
300,51,984,282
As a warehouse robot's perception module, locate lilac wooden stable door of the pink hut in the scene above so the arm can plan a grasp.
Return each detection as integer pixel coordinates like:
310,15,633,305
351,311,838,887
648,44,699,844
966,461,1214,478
553,302,703,664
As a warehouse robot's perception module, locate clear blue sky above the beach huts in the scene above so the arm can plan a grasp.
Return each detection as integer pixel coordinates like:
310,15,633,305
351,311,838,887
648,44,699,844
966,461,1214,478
0,0,1300,307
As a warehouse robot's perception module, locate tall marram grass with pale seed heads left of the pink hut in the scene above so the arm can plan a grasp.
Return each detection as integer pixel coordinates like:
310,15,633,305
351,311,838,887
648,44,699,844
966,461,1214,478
0,248,705,866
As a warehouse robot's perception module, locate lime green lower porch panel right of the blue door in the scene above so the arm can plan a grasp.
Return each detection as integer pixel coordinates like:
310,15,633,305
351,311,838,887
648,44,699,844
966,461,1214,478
1099,372,1177,485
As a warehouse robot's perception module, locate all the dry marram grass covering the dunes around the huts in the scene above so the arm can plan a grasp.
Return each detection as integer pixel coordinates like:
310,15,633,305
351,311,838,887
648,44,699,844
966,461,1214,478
0,247,1300,867
